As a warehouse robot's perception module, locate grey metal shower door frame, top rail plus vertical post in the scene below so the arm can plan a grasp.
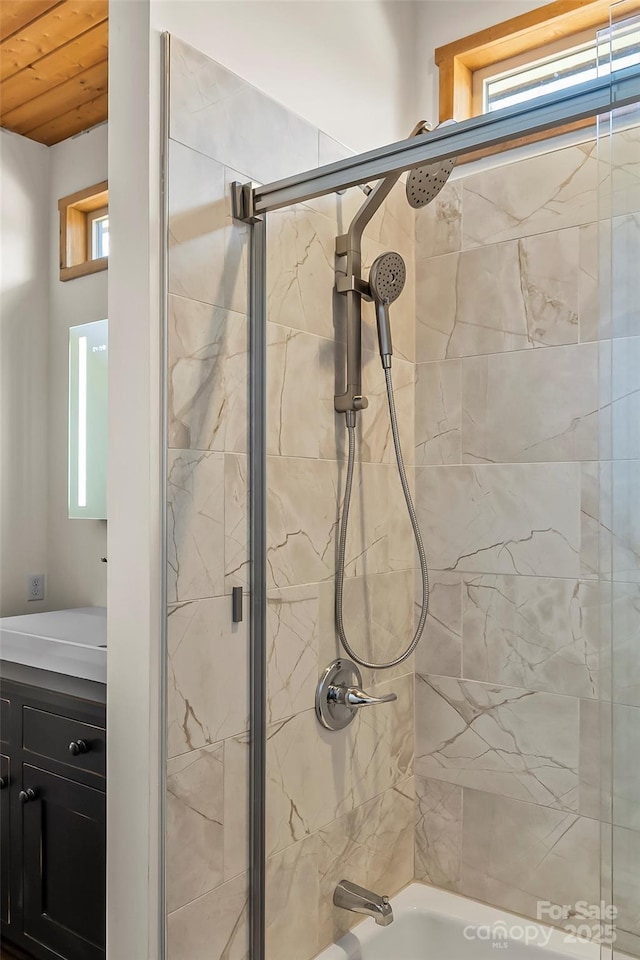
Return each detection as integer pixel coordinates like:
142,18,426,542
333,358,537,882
239,67,640,960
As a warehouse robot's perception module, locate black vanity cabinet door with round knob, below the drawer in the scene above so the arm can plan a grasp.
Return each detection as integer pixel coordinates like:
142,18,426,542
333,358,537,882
22,763,106,960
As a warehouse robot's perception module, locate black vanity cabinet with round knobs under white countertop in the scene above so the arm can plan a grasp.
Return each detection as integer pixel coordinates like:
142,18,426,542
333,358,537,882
0,663,106,960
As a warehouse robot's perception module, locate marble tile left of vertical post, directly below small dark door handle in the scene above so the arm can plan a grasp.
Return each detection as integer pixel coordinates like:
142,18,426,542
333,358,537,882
167,597,249,757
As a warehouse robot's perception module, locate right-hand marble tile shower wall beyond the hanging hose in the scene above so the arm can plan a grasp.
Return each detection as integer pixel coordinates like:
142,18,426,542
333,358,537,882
415,122,640,953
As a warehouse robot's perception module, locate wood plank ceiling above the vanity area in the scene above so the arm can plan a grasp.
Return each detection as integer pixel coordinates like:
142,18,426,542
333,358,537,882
0,0,109,146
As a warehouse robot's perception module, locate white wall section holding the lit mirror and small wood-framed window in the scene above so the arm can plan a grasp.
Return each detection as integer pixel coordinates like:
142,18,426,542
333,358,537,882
47,124,108,610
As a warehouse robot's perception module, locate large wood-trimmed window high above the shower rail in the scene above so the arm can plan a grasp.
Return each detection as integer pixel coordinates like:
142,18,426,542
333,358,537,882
435,0,640,127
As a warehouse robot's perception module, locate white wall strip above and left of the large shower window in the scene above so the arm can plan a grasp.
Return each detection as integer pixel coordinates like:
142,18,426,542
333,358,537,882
415,0,556,122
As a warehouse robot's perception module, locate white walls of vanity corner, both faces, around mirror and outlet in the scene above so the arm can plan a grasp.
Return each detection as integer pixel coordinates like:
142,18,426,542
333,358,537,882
0,125,108,616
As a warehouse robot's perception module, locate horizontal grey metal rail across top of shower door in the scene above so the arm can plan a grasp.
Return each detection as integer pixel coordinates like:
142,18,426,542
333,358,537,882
233,66,640,223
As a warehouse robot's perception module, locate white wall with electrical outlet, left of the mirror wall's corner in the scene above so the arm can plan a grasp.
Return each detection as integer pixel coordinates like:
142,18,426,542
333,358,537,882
0,130,49,616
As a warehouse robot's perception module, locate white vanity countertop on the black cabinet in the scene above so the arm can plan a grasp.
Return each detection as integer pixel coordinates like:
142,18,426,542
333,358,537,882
0,607,107,683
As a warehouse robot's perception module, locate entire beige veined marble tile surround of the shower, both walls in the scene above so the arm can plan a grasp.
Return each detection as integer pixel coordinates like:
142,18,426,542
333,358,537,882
167,31,640,960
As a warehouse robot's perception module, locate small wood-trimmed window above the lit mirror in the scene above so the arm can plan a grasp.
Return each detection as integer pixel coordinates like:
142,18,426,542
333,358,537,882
58,180,109,280
